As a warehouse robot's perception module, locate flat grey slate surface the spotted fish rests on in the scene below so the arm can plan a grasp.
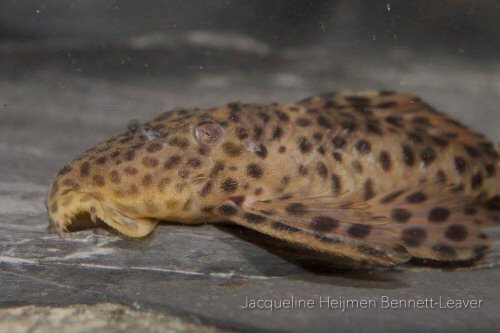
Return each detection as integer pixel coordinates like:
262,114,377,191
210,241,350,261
0,39,500,332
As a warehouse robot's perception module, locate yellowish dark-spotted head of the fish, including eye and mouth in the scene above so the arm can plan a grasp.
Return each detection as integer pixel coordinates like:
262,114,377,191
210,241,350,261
46,108,270,237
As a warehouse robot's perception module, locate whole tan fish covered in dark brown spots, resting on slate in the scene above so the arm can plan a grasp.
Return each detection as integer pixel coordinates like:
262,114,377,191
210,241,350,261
47,91,500,265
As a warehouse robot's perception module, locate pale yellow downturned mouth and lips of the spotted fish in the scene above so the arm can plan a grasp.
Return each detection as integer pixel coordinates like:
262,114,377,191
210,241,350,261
46,187,159,238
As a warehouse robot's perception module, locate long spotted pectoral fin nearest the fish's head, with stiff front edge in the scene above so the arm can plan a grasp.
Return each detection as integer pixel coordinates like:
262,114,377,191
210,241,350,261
217,199,410,266
